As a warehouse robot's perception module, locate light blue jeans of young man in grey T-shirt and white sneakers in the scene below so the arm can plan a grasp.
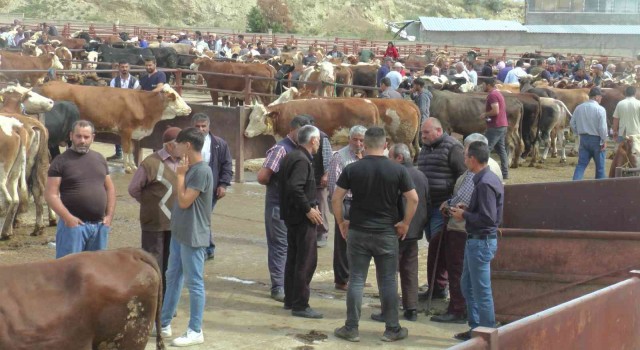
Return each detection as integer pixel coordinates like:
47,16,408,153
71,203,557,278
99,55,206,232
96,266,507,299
160,238,207,332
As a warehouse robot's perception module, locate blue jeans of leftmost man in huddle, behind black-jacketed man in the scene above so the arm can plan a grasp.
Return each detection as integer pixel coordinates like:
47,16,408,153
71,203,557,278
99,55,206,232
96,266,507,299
264,201,288,292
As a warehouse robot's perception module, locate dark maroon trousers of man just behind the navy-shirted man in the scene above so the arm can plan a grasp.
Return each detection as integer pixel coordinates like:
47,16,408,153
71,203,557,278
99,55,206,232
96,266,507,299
440,230,467,315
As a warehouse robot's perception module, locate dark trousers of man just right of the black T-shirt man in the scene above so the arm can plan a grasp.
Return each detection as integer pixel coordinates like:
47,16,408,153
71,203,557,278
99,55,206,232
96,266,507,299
398,240,420,310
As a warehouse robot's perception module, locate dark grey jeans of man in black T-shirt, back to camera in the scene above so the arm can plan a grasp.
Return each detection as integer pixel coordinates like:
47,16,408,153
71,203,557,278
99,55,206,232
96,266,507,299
345,228,400,329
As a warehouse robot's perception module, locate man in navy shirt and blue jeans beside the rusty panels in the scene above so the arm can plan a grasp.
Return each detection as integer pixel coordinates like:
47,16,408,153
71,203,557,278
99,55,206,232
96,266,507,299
450,141,504,341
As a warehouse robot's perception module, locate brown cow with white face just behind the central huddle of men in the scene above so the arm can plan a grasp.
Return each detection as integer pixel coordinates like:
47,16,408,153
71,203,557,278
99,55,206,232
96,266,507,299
244,98,381,140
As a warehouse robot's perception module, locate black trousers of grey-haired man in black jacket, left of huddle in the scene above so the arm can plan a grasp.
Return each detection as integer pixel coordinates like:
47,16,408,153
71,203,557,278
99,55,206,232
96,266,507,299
284,222,318,311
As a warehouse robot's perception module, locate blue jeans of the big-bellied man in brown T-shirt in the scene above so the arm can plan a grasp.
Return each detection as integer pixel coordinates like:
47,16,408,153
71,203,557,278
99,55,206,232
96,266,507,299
56,218,111,259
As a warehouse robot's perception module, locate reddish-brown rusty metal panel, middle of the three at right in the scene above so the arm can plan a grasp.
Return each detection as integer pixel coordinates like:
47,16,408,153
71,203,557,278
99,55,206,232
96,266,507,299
491,228,640,322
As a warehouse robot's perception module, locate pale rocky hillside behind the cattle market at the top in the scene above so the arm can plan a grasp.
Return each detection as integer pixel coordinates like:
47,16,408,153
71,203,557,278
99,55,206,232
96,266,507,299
0,0,523,38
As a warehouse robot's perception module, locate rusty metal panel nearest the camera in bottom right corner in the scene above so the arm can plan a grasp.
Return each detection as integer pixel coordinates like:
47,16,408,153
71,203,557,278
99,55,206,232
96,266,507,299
498,278,640,350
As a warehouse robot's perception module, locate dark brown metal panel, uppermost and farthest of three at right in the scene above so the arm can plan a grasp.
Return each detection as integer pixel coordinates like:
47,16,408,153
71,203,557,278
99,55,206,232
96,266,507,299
503,177,640,231
